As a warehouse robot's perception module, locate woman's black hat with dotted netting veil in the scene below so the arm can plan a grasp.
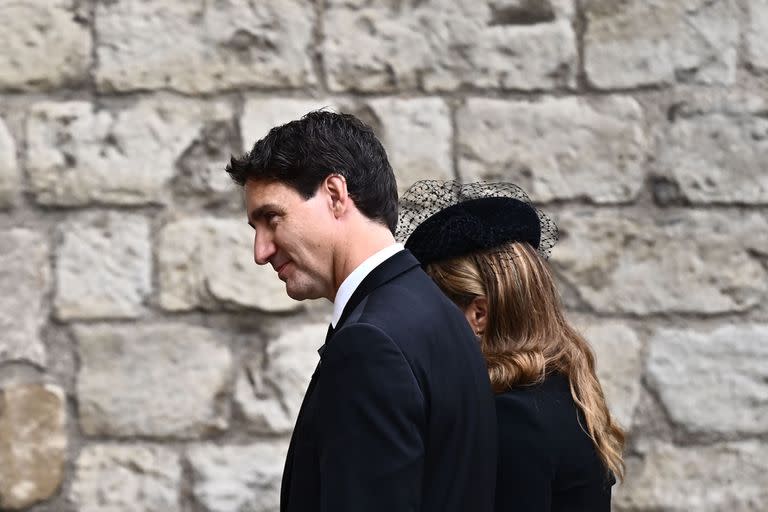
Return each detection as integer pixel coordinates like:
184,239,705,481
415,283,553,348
396,180,557,266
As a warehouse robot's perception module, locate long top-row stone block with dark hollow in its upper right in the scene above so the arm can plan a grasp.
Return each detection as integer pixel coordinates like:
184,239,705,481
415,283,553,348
323,0,577,92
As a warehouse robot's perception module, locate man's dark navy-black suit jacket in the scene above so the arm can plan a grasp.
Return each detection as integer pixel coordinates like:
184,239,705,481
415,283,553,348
280,251,496,512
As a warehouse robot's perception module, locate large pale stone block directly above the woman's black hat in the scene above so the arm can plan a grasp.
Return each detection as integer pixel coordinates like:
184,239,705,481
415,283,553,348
457,97,648,203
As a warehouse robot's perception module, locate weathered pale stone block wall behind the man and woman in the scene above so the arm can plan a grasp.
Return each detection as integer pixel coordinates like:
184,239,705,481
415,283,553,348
0,0,768,512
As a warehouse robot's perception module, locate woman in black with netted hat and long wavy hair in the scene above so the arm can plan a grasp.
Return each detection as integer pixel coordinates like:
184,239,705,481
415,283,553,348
398,181,624,512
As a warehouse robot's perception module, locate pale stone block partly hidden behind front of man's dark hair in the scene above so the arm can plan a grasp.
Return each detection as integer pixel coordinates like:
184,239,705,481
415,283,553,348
240,98,338,151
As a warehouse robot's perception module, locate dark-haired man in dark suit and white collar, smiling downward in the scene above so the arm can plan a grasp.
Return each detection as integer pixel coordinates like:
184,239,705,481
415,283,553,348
227,111,496,512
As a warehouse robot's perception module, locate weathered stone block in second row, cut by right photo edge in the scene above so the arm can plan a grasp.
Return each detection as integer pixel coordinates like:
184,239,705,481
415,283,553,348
658,105,768,204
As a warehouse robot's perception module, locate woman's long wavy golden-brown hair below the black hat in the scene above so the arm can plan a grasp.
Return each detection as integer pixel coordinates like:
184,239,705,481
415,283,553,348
426,242,624,479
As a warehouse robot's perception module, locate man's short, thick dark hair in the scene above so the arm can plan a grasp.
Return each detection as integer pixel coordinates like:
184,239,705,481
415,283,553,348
227,110,397,233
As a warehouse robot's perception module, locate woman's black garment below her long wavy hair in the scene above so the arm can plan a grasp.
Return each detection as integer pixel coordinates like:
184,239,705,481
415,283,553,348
496,373,615,512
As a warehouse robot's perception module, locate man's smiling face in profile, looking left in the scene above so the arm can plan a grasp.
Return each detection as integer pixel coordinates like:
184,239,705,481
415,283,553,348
245,181,334,300
